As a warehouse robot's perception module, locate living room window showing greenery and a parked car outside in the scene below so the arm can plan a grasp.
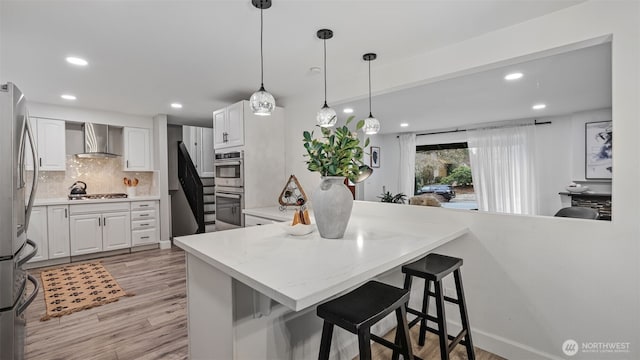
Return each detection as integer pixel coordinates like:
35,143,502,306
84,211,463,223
415,142,477,209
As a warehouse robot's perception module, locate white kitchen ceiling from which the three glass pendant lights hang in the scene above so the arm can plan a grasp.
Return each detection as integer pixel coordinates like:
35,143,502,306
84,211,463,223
0,0,581,127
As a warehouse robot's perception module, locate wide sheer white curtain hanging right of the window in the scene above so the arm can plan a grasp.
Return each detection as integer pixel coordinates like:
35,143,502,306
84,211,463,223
467,125,538,215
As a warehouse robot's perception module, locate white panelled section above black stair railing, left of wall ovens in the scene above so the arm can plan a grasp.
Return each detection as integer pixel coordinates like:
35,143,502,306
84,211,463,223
182,126,215,177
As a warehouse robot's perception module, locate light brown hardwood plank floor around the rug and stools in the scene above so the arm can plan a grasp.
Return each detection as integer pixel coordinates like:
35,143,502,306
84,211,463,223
26,248,502,360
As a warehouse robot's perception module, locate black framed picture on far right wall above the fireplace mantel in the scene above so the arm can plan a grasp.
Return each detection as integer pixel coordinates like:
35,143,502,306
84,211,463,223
584,121,613,179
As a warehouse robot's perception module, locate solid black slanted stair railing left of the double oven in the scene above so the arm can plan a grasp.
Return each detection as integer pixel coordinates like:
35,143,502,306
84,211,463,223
178,141,205,233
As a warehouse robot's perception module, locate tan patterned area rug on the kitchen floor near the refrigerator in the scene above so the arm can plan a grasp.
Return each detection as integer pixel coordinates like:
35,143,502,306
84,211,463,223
40,262,132,321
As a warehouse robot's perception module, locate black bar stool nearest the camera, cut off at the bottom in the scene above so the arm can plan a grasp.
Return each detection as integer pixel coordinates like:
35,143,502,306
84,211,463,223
317,281,413,360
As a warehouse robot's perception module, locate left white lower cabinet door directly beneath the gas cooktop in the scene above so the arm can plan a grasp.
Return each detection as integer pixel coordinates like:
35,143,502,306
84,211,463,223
69,214,102,256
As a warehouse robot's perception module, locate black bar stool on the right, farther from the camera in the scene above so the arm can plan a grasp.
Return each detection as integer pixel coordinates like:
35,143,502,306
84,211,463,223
393,254,476,360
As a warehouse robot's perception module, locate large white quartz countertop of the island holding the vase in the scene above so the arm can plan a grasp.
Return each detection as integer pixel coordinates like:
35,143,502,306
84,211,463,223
174,208,469,311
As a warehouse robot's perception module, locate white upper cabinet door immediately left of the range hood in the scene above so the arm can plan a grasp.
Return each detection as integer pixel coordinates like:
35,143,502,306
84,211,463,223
38,119,67,171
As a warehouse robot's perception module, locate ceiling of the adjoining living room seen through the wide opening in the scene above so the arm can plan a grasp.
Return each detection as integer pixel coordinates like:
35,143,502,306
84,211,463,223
342,42,612,133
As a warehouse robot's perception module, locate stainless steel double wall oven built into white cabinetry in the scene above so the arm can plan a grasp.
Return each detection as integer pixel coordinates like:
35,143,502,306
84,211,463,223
213,151,244,230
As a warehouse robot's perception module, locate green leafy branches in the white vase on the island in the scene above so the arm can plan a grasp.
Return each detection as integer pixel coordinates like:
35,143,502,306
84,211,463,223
302,116,369,181
